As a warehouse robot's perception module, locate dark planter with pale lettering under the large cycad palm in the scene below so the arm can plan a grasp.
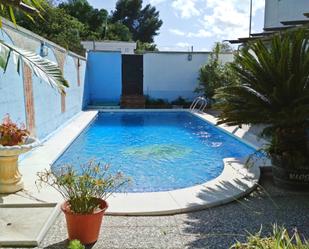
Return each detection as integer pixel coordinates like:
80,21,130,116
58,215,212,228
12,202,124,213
272,157,309,191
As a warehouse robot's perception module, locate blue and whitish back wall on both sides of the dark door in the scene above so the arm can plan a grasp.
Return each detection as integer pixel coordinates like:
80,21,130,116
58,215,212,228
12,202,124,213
84,51,233,106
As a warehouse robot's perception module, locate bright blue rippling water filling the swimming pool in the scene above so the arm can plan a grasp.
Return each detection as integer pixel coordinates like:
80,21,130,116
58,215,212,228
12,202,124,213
53,112,255,192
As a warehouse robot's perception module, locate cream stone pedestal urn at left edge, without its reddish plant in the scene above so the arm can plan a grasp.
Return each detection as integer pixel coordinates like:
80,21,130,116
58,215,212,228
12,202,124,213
0,137,39,194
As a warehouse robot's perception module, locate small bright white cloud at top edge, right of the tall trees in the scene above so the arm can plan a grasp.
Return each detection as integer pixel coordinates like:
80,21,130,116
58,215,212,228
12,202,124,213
172,0,201,18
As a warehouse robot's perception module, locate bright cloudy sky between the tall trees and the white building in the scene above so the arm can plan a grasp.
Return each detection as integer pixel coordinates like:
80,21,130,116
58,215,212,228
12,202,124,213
147,0,265,50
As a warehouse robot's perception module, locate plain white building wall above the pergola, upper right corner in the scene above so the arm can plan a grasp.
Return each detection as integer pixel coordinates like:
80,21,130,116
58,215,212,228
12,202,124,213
264,0,309,28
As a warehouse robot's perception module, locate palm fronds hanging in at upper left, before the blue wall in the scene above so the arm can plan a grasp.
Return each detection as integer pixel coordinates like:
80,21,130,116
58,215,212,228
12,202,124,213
0,0,69,93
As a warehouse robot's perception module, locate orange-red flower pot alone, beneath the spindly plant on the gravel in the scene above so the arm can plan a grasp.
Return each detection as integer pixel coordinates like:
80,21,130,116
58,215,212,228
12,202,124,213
61,200,108,245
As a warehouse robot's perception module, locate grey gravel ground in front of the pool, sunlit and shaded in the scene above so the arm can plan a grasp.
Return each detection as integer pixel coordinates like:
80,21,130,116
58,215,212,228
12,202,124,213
9,177,309,249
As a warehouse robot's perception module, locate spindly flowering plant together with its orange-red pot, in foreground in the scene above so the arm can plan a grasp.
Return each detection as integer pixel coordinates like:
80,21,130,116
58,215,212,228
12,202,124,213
36,161,128,244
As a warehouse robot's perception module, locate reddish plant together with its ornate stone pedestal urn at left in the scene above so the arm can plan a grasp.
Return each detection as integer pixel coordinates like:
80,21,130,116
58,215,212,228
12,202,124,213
0,114,38,194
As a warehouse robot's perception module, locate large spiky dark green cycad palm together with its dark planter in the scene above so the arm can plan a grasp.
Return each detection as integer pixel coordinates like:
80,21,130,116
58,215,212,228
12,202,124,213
215,29,309,189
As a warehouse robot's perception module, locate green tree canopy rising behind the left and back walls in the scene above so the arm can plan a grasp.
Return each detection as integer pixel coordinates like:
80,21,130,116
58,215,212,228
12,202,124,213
11,0,162,55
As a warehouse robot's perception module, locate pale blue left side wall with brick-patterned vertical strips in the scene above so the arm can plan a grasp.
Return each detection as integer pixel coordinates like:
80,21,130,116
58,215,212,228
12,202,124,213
0,20,86,139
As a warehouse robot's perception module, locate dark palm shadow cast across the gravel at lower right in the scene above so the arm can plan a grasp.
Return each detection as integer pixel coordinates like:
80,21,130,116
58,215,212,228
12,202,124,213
181,175,309,249
